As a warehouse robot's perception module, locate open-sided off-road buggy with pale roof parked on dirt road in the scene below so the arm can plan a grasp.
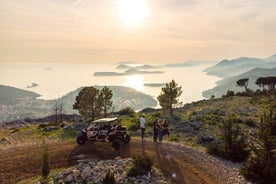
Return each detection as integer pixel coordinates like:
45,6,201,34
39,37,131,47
77,118,130,151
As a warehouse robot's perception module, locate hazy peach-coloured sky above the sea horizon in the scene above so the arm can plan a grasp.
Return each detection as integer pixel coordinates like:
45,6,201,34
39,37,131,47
0,0,276,63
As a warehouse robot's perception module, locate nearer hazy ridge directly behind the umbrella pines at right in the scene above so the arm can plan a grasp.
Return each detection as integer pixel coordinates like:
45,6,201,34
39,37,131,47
202,67,276,98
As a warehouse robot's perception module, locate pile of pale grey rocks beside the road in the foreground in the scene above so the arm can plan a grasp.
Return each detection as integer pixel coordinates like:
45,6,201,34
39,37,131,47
46,157,169,184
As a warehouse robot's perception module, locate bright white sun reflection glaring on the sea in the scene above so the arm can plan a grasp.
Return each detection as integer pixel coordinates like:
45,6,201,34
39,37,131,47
123,75,144,91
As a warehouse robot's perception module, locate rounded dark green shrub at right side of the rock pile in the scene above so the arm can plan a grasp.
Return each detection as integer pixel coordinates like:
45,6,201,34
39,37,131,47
127,155,153,177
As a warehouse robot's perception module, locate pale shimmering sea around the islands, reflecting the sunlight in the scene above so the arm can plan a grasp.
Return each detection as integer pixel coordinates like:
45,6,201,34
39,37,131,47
0,63,220,104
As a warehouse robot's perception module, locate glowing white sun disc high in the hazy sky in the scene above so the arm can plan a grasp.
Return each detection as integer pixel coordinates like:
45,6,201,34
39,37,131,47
119,0,149,26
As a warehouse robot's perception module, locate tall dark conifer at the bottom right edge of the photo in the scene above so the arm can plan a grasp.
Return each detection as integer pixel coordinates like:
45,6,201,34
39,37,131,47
241,110,276,183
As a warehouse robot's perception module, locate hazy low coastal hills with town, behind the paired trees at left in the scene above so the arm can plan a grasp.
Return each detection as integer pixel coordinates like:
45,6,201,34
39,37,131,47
0,85,157,122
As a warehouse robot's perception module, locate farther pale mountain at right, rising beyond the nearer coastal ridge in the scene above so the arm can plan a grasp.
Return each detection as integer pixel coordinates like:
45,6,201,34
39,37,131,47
204,55,276,78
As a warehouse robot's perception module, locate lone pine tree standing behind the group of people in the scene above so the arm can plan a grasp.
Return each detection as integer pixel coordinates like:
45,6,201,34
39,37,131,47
157,80,182,116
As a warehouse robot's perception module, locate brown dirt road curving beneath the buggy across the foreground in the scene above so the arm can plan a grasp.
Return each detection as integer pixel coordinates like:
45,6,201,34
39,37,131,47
0,139,226,184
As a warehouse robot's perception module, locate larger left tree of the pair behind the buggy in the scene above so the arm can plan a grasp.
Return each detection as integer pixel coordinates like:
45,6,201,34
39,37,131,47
73,87,102,121
